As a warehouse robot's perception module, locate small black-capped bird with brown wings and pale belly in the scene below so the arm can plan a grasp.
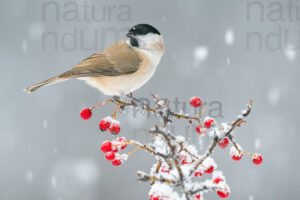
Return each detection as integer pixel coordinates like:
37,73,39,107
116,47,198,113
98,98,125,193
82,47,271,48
25,24,165,97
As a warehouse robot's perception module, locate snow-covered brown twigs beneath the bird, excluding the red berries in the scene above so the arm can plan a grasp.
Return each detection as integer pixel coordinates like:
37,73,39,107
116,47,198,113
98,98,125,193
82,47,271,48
92,95,256,200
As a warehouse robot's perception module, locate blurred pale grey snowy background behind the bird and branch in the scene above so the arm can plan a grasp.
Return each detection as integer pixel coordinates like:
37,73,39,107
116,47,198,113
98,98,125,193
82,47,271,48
0,0,300,200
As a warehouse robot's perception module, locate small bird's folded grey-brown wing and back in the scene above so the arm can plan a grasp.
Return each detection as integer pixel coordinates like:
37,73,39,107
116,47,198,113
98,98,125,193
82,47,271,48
59,41,141,78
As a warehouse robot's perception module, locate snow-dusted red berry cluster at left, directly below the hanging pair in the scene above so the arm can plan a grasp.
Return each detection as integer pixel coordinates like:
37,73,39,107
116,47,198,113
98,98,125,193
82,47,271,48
101,137,128,166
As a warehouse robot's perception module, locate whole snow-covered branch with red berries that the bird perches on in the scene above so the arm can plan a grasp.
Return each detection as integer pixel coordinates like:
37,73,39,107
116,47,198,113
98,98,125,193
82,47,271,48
80,95,263,200
